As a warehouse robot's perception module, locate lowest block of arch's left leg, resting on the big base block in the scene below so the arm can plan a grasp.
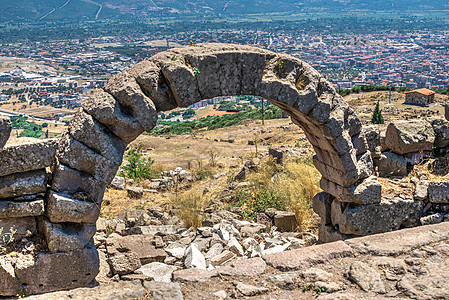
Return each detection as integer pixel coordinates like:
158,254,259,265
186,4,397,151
39,217,96,253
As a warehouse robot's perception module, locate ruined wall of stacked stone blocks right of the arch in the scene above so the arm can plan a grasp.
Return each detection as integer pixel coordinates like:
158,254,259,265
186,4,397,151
313,118,449,242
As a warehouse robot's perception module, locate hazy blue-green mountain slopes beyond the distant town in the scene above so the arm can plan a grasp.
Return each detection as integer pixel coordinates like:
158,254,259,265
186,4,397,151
0,0,449,23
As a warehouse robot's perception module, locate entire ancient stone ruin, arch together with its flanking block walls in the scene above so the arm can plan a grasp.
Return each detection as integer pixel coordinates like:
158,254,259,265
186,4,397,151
0,44,449,296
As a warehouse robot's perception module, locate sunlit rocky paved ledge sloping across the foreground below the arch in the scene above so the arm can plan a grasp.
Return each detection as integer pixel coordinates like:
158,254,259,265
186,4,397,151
24,222,449,300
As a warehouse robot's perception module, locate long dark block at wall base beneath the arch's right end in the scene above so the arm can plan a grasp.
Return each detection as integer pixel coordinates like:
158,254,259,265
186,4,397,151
338,198,424,235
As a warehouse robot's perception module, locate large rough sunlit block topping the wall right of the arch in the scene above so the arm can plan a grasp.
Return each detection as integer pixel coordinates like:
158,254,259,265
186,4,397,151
385,120,435,154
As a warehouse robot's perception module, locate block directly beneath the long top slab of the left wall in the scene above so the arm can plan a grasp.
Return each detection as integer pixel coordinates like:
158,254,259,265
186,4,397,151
0,169,47,201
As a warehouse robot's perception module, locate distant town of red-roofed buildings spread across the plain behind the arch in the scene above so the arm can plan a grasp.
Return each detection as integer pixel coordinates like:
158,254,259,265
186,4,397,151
0,30,449,118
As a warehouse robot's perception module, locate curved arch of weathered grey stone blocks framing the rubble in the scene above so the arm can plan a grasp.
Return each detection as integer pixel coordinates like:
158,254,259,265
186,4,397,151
36,44,373,287
